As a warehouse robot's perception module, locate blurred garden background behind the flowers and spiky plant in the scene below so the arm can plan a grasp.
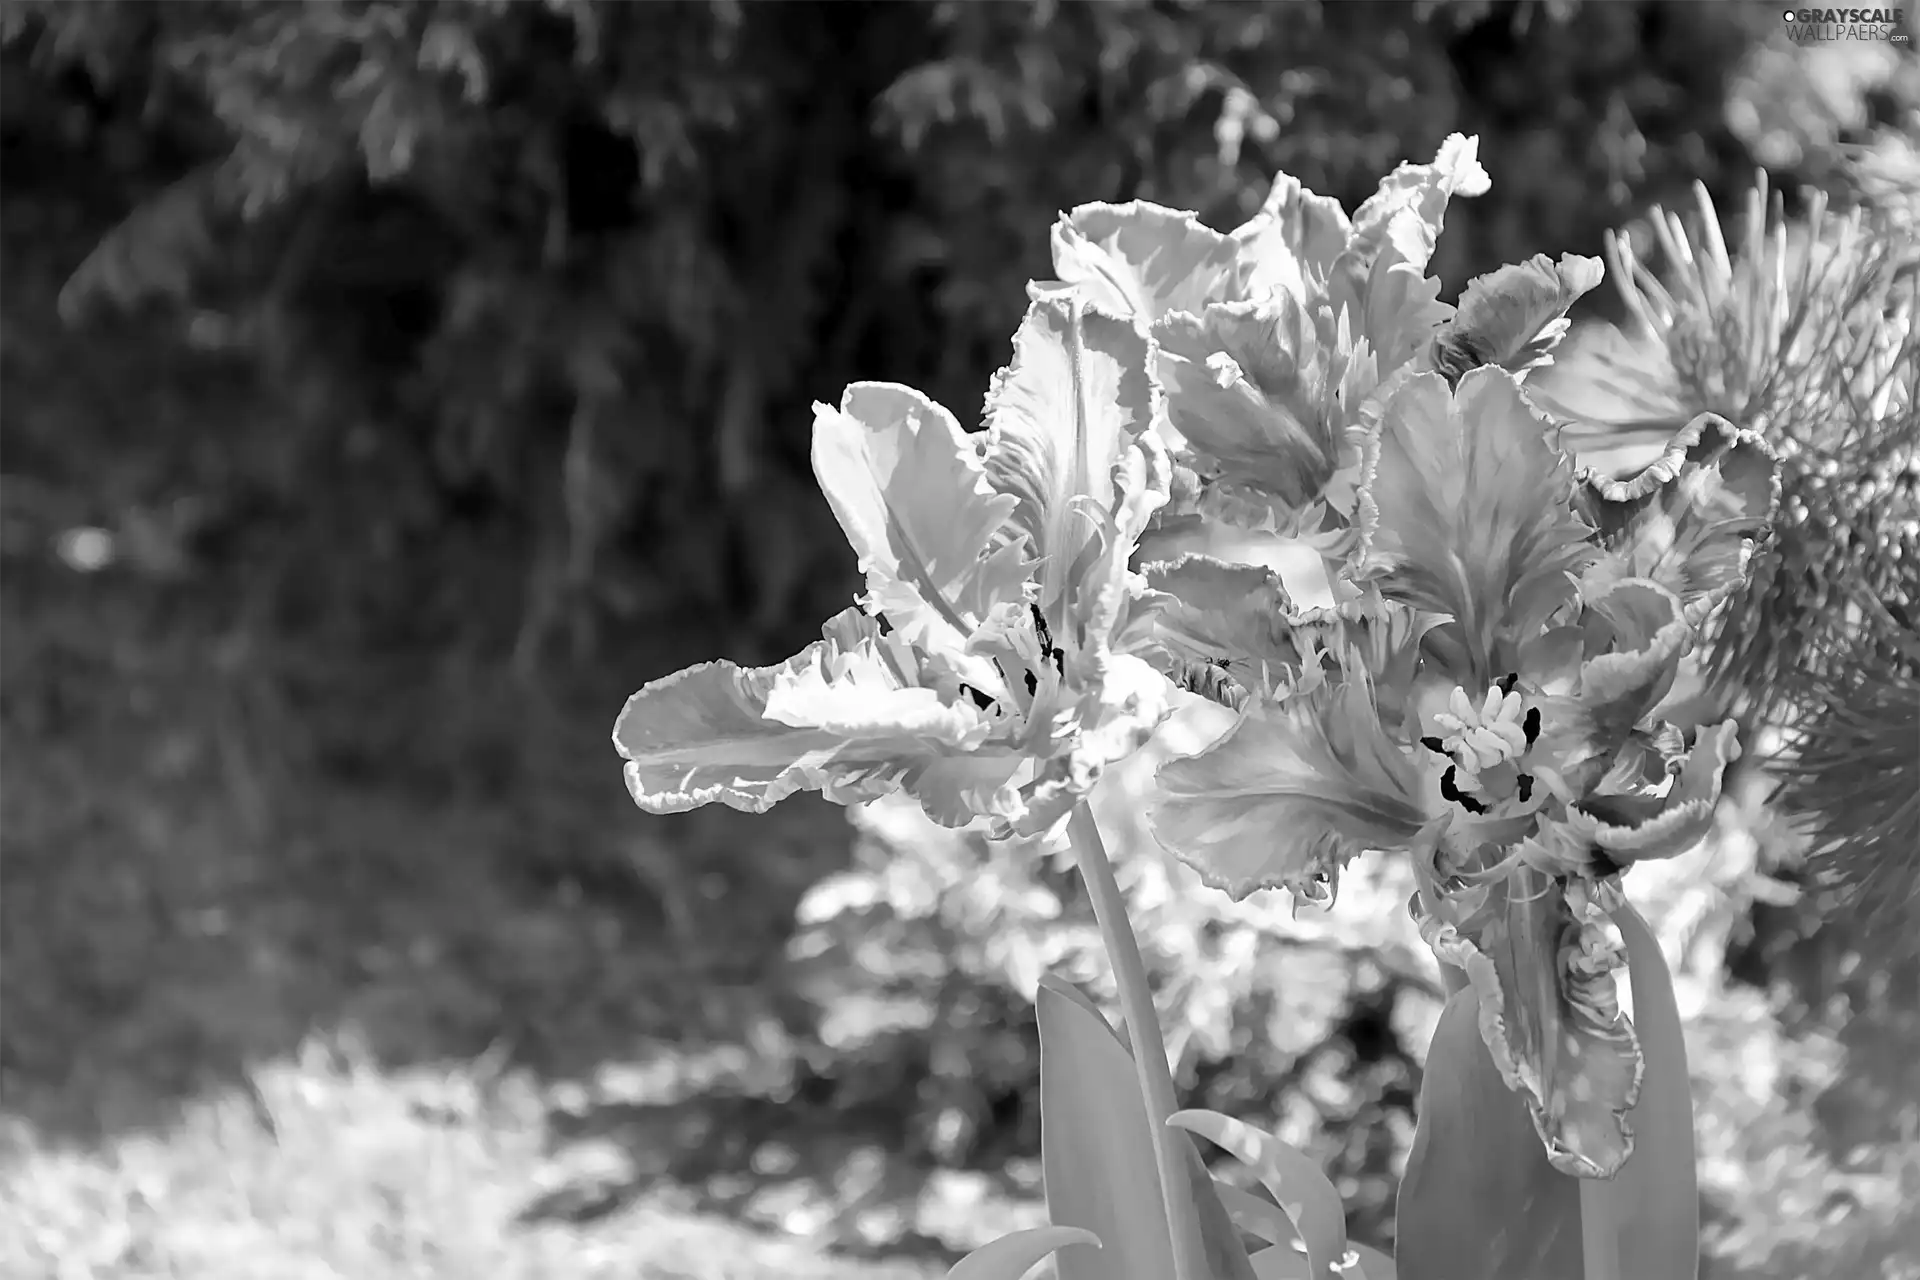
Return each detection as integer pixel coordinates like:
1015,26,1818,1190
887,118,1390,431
0,0,1920,1280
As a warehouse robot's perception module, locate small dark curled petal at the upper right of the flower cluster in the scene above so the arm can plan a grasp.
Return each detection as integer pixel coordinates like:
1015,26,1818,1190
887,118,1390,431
1432,253,1605,382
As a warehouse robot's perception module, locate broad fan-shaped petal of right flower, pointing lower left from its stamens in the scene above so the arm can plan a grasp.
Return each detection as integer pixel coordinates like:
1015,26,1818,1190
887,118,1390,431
1148,664,1428,900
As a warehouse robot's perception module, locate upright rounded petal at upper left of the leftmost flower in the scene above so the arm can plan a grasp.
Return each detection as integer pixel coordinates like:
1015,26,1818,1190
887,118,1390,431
812,382,1025,651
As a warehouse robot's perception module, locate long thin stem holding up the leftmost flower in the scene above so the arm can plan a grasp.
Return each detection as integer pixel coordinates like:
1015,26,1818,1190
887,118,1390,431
1068,800,1208,1280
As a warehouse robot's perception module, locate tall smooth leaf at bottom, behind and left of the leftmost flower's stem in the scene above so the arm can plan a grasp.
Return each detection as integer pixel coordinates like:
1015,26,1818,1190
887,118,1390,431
1033,979,1173,1280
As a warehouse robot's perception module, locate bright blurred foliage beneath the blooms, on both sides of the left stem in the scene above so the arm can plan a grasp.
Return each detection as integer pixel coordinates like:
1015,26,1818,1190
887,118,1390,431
789,699,1442,1240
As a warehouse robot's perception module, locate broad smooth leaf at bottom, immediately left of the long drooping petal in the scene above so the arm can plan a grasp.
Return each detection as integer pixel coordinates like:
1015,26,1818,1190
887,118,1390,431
1394,990,1582,1280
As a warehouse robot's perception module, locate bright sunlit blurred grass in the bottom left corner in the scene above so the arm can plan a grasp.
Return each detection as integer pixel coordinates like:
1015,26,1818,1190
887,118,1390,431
0,1042,952,1280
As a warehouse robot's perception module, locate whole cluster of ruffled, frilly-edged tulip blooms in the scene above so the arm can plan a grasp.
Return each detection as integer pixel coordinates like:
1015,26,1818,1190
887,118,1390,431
614,136,1778,1274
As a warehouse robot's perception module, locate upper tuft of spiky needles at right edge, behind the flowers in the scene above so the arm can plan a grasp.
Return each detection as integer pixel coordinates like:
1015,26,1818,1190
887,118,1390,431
1542,175,1920,718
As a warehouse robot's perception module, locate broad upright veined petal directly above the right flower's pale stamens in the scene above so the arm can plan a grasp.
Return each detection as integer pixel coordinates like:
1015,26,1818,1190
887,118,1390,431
1363,368,1590,689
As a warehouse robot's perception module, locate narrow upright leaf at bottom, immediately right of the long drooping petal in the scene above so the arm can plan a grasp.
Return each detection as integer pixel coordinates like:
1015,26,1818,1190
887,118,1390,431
1590,906,1699,1280
